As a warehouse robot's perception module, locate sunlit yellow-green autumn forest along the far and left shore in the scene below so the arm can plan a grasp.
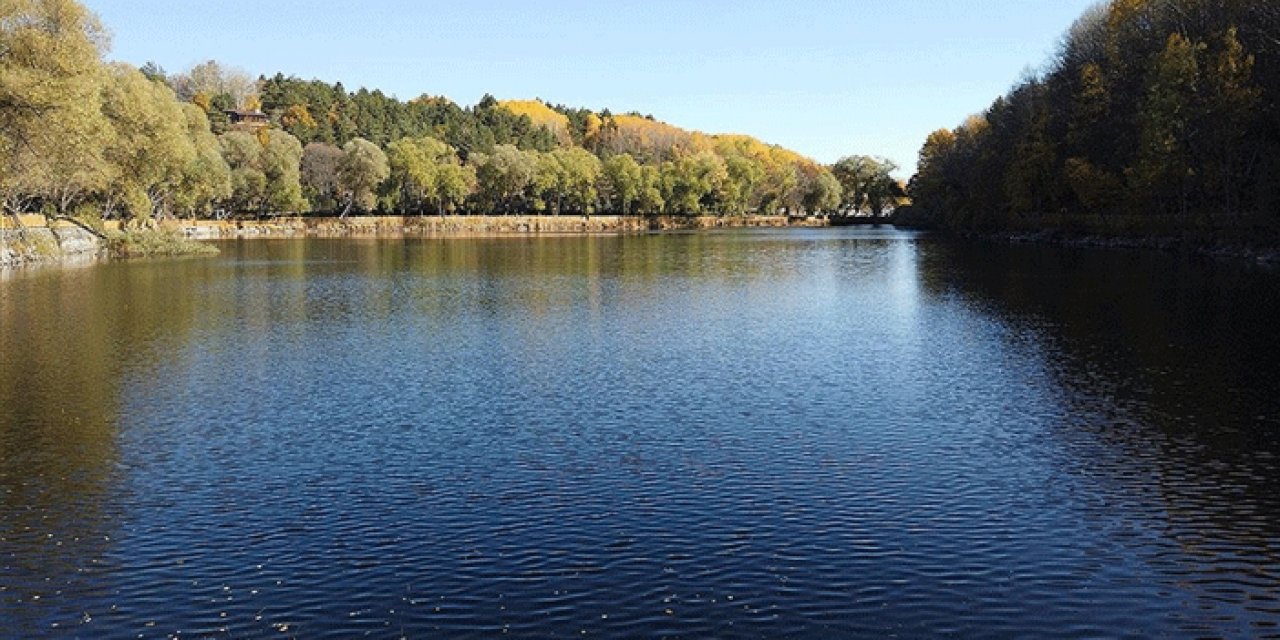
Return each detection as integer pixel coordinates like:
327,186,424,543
0,0,902,225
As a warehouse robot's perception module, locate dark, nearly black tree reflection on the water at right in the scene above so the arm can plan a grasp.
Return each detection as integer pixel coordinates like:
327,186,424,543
920,242,1280,604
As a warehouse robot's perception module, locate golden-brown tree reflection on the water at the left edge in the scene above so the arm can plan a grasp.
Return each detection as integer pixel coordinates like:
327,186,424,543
0,257,212,636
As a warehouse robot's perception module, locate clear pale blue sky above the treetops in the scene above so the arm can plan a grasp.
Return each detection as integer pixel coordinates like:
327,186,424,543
86,0,1094,175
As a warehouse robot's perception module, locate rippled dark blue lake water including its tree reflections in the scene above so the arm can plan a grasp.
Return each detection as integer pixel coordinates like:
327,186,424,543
0,229,1280,639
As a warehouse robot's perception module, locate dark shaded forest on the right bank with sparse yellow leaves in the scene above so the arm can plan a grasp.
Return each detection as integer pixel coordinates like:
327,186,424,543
910,0,1280,239
